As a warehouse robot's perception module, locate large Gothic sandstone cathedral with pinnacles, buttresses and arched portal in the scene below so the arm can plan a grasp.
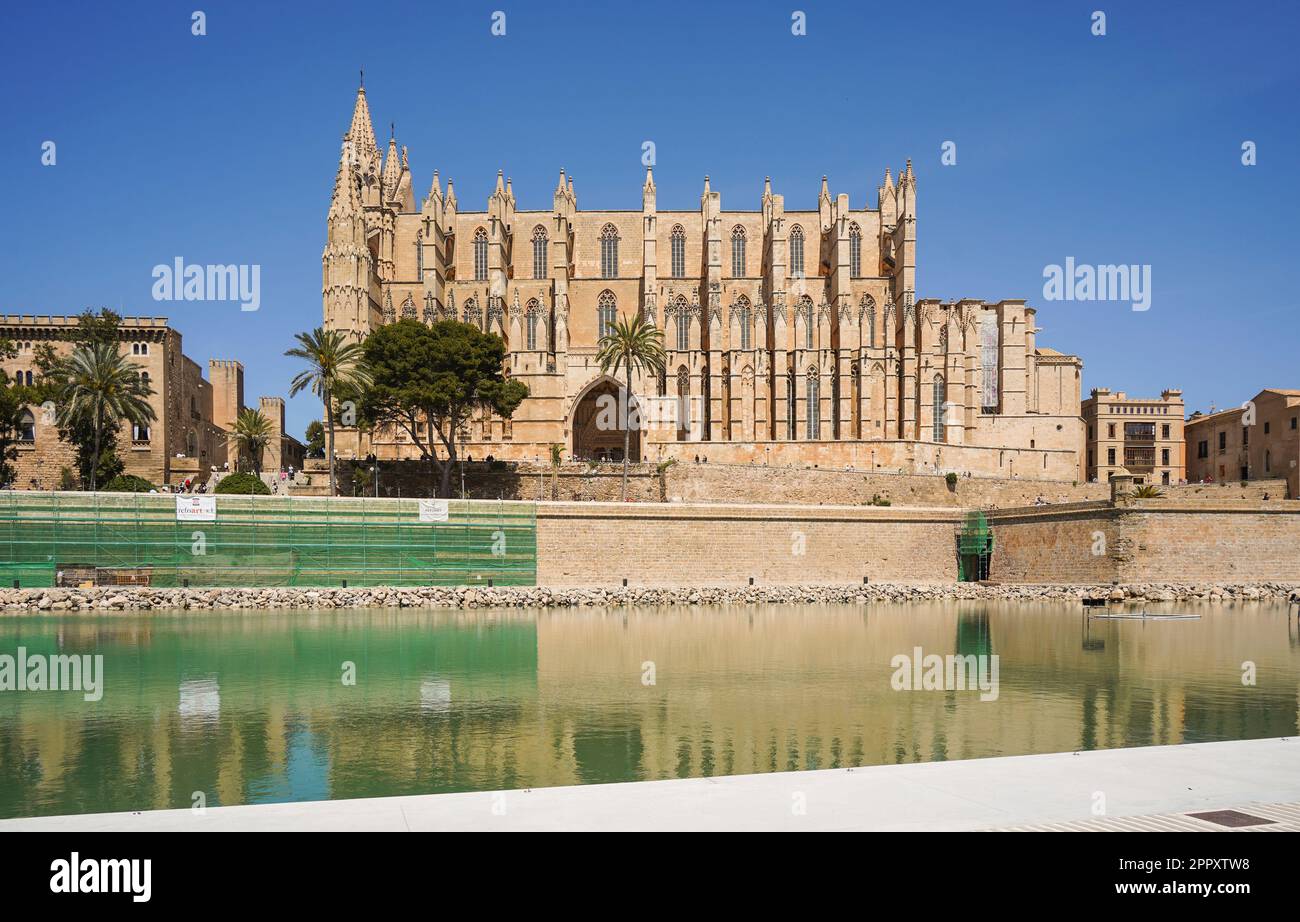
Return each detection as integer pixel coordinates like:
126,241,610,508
322,87,1083,480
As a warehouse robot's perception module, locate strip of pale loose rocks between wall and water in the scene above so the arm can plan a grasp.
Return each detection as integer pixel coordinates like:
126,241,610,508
0,583,1300,614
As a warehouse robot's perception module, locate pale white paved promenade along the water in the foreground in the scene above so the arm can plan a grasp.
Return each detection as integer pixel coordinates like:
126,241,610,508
0,739,1300,832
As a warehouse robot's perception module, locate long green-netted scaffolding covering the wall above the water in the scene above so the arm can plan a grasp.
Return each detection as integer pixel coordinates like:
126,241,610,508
0,490,537,586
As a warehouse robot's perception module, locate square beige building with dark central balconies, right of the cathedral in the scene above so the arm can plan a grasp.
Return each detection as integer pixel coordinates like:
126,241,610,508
1083,388,1187,484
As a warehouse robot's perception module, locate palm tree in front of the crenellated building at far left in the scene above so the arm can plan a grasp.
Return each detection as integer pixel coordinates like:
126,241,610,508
49,342,157,492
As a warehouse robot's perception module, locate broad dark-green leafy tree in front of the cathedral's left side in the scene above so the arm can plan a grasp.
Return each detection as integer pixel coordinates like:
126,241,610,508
360,320,528,497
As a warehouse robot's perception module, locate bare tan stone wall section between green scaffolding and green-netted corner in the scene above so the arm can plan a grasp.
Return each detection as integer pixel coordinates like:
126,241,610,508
537,503,959,586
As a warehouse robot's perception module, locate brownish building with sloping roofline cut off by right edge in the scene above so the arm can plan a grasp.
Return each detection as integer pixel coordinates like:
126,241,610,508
1184,388,1300,499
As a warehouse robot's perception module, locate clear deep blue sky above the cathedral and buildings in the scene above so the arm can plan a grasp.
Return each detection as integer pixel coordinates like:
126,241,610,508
0,0,1300,433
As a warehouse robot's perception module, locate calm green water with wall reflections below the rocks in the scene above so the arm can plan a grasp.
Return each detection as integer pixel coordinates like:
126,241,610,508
0,603,1300,817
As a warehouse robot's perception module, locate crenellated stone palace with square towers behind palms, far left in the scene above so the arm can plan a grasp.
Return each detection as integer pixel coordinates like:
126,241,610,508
0,315,303,490
